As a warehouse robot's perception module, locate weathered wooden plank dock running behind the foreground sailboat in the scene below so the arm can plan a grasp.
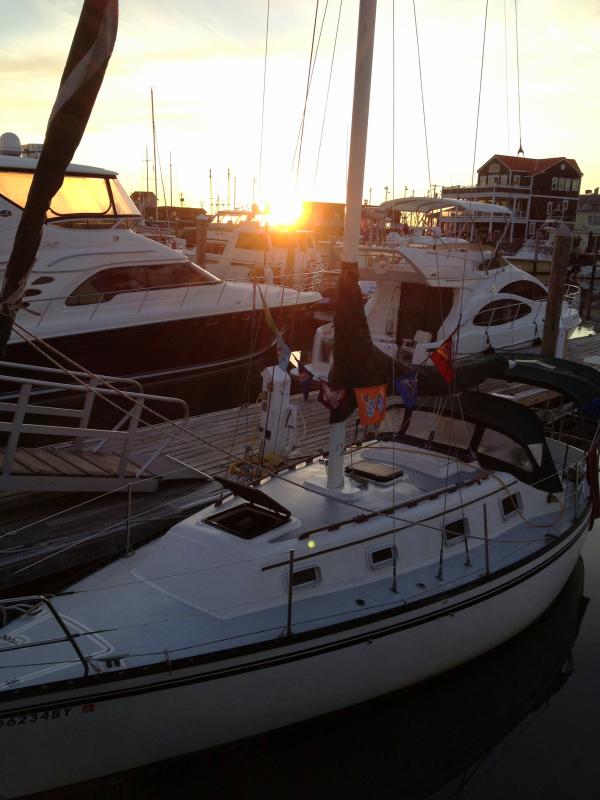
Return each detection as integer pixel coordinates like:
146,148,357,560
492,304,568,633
0,334,600,596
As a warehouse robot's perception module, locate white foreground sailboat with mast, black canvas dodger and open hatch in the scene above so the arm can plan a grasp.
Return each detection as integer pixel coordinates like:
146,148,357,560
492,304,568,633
0,0,600,797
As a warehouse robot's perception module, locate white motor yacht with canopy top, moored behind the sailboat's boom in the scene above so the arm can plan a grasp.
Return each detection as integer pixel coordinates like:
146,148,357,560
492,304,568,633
309,197,581,378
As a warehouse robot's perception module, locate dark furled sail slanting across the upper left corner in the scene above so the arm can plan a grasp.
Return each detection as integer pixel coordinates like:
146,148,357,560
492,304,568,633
0,0,118,356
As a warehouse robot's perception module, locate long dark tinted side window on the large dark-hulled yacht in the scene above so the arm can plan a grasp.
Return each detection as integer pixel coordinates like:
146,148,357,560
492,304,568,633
65,261,220,306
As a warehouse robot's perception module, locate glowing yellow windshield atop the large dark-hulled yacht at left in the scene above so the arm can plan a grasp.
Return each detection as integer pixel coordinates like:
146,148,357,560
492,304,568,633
0,171,140,219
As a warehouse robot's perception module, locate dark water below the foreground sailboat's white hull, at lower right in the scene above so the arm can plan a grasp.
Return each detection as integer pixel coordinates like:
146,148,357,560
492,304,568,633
36,523,600,800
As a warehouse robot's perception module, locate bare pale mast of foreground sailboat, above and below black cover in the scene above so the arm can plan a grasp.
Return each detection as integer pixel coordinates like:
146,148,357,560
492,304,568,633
327,0,377,489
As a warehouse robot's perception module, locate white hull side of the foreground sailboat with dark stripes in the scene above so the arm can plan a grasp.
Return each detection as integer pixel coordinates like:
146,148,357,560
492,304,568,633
0,514,589,797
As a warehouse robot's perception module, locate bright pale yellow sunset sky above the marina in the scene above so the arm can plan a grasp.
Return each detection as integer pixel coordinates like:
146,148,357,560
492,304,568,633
0,0,600,216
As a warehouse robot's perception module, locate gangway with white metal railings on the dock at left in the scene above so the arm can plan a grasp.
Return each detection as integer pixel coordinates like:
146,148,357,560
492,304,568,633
0,361,204,492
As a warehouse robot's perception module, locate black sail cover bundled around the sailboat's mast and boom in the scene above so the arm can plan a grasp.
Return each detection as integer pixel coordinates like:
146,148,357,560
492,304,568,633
329,263,509,421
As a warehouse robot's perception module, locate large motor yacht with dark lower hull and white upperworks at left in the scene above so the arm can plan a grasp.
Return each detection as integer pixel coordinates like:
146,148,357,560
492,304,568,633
0,138,319,406
